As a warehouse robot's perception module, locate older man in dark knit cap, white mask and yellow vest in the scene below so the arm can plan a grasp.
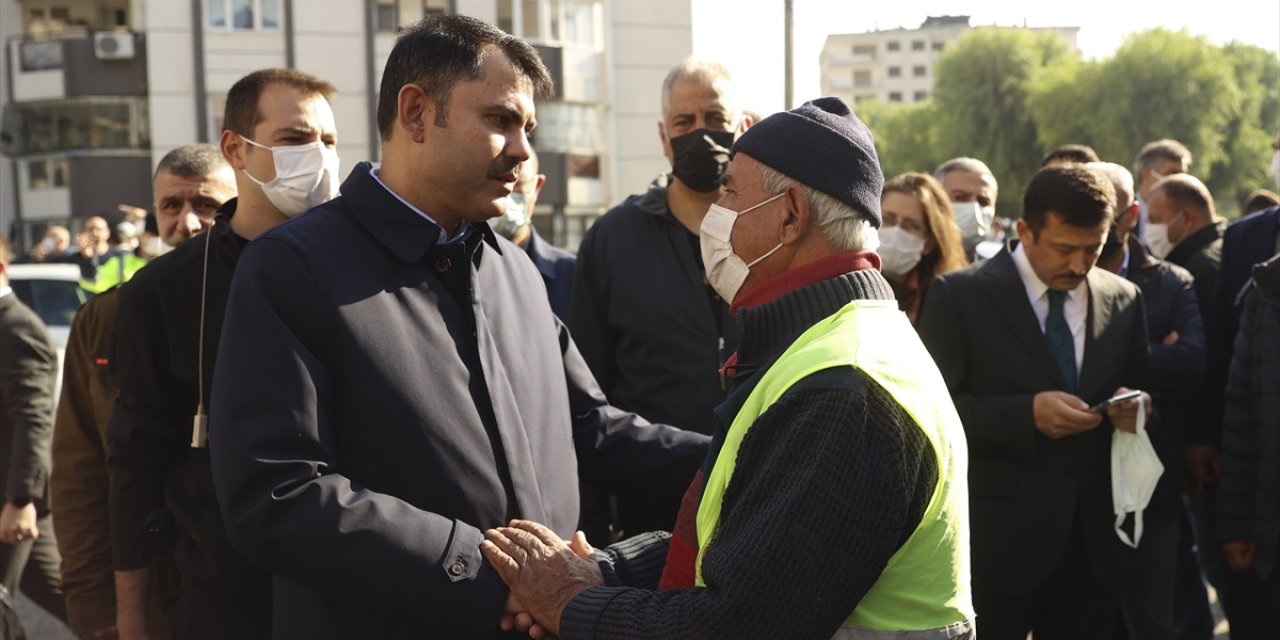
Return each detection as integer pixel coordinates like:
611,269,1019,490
483,97,974,639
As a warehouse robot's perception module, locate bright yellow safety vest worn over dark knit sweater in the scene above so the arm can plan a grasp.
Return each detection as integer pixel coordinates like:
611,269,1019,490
695,301,974,631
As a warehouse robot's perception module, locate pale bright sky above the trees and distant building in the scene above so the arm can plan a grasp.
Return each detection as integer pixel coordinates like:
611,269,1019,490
690,0,1280,114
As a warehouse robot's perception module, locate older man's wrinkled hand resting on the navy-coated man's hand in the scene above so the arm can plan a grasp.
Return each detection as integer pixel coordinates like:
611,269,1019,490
480,520,604,637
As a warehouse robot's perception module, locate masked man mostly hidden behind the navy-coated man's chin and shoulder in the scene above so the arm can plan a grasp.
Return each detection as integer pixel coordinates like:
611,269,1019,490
489,148,577,323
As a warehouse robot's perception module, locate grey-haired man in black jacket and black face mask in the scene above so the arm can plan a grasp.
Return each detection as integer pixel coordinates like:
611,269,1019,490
568,60,751,544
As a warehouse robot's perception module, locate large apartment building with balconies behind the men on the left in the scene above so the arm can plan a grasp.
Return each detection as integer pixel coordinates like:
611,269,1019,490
0,0,692,247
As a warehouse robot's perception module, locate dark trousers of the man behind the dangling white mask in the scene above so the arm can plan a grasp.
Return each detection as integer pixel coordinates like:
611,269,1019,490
1120,513,1181,640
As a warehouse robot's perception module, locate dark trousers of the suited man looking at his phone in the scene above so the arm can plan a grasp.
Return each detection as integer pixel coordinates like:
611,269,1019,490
973,524,1120,640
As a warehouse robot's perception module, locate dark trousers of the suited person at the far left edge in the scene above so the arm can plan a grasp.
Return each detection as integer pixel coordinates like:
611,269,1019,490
0,513,67,622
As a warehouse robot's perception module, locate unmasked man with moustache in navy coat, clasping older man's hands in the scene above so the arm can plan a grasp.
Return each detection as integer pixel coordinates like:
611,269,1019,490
210,15,707,639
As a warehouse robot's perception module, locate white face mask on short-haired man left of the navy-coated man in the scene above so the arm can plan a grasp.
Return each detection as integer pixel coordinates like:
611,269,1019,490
241,136,338,218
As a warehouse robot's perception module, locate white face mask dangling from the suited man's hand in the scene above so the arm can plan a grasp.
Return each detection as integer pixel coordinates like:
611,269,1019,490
1111,401,1165,549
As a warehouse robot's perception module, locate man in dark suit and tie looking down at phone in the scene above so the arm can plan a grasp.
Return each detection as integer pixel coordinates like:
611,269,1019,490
918,165,1151,640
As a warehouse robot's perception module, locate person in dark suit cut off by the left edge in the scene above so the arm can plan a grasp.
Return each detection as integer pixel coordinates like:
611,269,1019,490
0,236,67,620
